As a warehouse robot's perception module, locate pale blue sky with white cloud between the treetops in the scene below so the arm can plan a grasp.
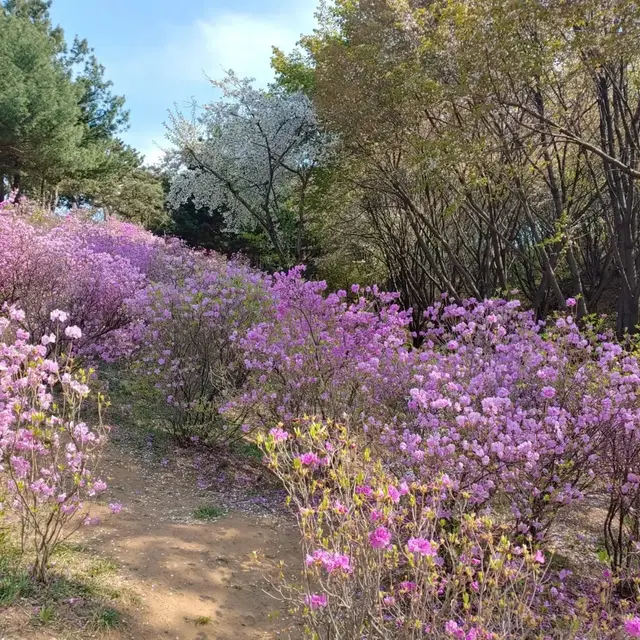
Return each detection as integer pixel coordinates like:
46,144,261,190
51,0,316,162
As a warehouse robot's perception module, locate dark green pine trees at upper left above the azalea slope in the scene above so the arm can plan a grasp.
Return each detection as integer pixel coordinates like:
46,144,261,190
0,0,164,222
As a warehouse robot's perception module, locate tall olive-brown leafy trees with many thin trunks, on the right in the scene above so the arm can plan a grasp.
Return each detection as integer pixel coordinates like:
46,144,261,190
258,0,640,331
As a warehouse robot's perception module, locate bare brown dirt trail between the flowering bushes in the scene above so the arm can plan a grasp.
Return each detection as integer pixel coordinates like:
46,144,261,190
83,445,299,640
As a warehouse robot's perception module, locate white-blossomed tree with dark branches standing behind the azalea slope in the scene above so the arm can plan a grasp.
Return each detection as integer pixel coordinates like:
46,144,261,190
167,71,331,267
